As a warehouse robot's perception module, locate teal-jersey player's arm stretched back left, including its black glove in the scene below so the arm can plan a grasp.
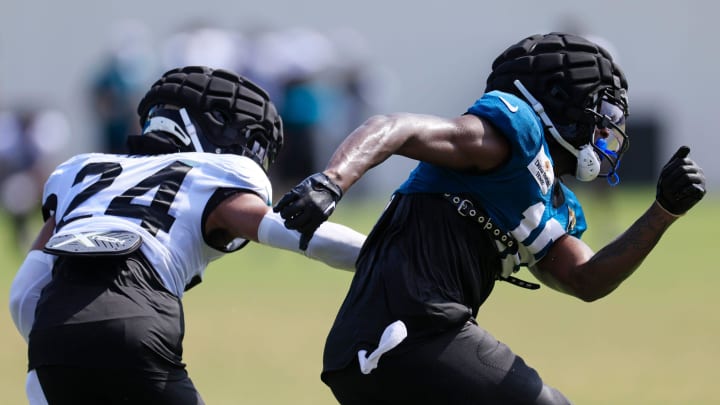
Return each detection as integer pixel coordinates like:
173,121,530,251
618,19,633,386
274,113,510,249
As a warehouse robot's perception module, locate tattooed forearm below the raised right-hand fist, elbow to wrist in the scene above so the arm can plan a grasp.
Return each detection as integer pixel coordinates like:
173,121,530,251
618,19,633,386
575,203,677,301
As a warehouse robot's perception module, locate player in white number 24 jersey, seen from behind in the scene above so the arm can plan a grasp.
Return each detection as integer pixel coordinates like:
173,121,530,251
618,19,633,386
10,66,365,405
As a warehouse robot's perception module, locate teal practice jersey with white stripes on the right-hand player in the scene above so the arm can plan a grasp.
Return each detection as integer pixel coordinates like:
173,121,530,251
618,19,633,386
397,91,587,266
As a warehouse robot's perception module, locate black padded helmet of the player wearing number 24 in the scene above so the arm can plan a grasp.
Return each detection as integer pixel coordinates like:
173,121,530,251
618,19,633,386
128,66,283,171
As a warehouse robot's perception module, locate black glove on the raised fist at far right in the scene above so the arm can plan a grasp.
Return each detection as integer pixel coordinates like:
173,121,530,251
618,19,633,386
655,146,705,216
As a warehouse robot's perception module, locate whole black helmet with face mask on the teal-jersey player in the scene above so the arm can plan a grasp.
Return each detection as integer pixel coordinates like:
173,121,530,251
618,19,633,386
485,32,629,182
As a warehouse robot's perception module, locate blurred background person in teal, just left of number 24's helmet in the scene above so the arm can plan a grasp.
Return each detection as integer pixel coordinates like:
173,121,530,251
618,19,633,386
89,20,158,153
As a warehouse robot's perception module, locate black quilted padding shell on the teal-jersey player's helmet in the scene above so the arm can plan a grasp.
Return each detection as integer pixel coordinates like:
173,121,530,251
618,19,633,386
485,32,628,149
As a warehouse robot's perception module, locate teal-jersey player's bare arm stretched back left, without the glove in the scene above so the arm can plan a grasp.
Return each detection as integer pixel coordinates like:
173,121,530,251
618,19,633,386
324,113,509,191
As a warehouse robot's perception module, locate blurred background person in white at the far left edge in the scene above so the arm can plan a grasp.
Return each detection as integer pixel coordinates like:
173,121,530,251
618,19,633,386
0,104,70,251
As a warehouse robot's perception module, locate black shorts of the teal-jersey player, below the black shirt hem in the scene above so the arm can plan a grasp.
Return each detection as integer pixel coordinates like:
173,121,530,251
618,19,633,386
322,322,570,405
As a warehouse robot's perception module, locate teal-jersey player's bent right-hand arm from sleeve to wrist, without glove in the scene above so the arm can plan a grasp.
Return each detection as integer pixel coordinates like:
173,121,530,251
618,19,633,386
530,202,677,302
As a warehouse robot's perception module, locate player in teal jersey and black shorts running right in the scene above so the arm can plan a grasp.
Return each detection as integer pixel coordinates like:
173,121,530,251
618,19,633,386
275,33,705,404
